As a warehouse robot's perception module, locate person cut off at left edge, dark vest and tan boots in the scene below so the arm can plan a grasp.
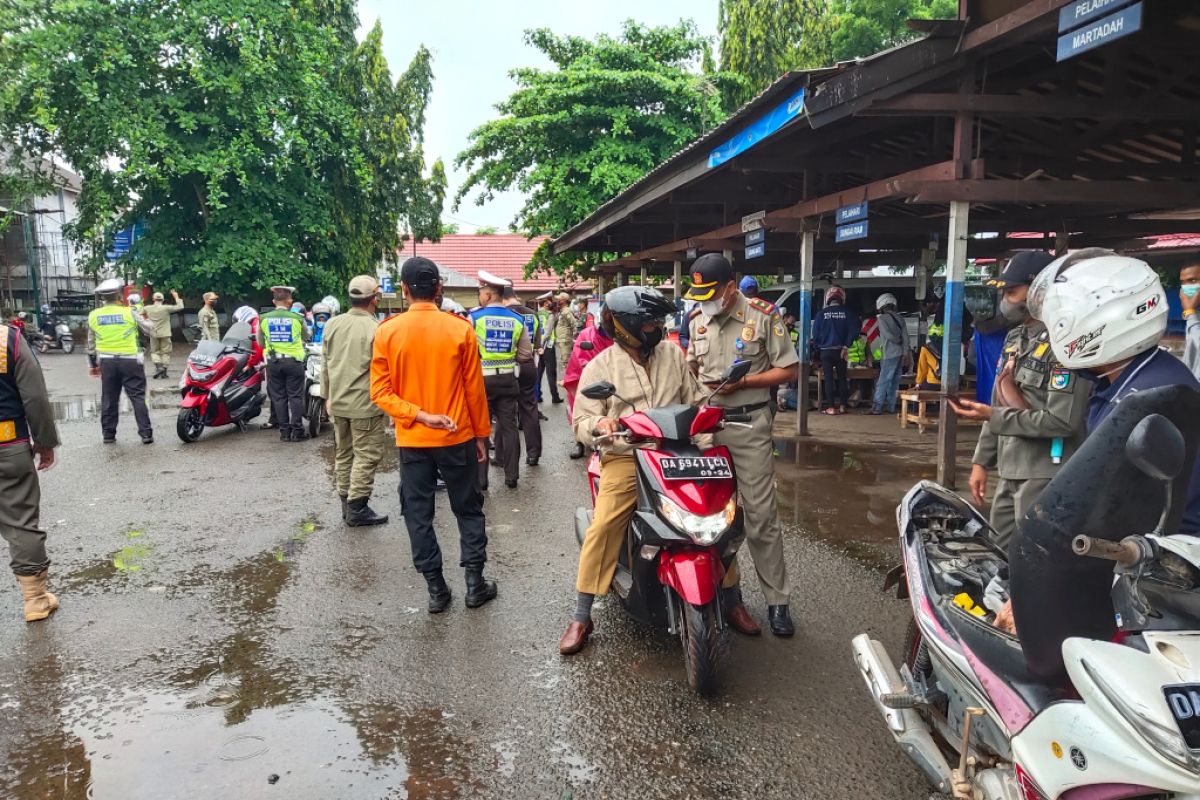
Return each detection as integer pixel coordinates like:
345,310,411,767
0,325,59,622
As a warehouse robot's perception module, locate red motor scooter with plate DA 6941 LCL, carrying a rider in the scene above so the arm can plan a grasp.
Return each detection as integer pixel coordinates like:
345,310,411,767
575,361,750,694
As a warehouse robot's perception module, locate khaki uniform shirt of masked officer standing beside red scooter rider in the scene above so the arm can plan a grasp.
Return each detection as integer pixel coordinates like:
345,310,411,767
688,291,799,408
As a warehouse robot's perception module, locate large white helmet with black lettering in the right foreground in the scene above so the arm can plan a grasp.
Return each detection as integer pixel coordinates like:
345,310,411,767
1026,247,1168,369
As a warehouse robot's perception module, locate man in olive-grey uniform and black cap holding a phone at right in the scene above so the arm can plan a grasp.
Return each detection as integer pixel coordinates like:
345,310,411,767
955,251,1092,548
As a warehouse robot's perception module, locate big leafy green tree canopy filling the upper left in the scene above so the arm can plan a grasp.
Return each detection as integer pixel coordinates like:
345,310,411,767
0,0,445,296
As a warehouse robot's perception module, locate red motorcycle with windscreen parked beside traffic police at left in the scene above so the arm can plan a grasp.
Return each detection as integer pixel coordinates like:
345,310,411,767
175,323,264,444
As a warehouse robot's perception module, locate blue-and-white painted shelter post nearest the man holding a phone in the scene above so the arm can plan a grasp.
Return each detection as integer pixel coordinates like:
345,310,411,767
937,200,971,489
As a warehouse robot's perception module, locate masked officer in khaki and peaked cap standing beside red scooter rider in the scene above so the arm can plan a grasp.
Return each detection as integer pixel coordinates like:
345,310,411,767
685,253,799,636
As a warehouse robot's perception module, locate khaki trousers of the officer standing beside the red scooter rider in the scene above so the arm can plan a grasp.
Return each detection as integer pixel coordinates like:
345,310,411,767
714,408,792,606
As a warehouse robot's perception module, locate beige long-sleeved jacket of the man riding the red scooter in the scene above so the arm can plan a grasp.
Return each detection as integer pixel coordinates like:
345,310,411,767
571,342,708,455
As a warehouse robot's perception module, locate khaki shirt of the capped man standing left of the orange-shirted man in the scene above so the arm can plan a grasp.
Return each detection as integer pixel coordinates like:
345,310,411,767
320,308,383,420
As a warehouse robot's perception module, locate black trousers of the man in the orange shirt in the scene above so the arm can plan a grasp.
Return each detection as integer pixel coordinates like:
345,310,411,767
400,439,487,575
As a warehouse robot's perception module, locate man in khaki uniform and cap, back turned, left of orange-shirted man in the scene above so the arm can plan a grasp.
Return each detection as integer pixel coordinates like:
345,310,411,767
320,275,388,528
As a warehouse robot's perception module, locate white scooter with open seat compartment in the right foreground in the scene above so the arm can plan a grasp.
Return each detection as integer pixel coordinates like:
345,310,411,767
852,386,1200,800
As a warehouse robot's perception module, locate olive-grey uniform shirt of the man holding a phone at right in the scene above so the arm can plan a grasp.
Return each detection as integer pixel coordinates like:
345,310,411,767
972,320,1092,481
